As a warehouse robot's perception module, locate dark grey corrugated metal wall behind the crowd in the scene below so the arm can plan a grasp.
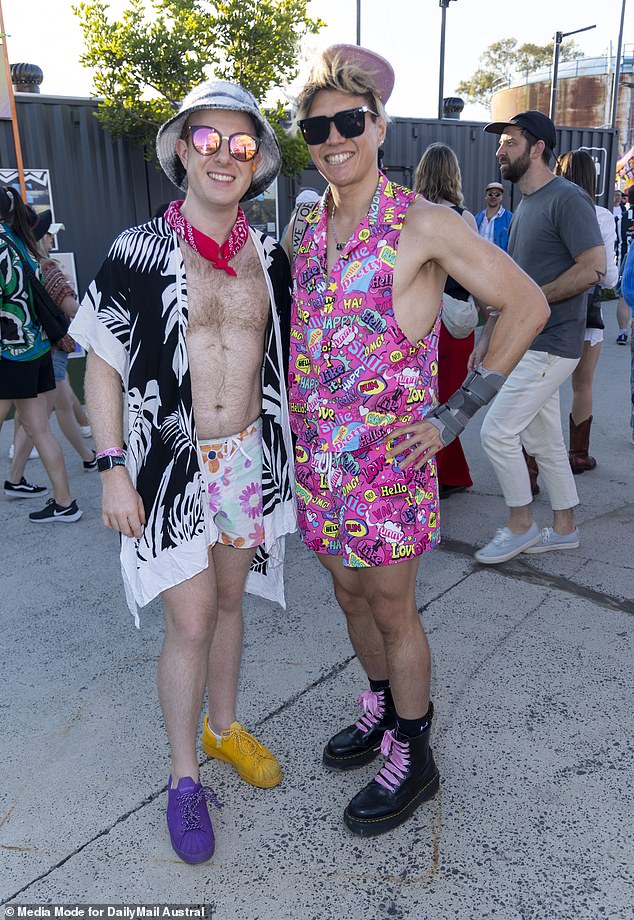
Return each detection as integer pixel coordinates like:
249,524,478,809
0,94,616,292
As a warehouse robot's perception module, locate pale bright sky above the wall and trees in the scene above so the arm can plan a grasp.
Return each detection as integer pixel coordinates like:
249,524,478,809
2,0,634,119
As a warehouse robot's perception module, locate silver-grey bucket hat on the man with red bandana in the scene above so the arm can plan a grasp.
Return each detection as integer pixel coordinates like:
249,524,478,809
156,80,282,201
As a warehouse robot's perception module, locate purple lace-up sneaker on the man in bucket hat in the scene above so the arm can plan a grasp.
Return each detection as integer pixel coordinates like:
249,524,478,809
167,776,220,864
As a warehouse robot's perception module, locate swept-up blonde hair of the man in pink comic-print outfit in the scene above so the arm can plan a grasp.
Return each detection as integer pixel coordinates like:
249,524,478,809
296,48,389,123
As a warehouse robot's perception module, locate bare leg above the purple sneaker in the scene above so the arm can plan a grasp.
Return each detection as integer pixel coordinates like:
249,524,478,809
157,552,216,786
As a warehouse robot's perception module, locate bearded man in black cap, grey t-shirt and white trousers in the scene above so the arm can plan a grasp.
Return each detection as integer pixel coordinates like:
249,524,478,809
475,111,605,564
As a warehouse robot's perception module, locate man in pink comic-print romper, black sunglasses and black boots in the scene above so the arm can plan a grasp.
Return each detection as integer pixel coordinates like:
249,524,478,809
289,45,548,836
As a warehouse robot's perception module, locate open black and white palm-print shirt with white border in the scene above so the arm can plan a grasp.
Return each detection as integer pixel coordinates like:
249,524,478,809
71,218,296,626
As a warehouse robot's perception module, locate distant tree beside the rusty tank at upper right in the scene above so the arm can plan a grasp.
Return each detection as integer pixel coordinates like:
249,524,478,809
457,38,580,105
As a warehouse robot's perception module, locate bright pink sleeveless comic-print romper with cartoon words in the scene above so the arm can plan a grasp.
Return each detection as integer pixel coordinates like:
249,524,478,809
289,173,440,568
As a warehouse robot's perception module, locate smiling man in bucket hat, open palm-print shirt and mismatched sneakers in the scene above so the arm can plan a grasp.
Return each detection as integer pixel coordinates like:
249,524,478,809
73,81,295,863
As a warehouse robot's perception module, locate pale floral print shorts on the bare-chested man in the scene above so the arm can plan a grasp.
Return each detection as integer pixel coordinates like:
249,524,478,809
198,419,264,549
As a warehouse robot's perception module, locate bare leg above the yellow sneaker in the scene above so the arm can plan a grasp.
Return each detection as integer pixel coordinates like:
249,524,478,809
207,543,255,734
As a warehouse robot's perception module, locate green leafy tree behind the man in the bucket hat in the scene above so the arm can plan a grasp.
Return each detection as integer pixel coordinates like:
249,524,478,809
73,0,324,175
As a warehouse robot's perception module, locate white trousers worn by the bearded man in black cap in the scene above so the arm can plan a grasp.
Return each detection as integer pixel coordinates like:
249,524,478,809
480,351,579,511
